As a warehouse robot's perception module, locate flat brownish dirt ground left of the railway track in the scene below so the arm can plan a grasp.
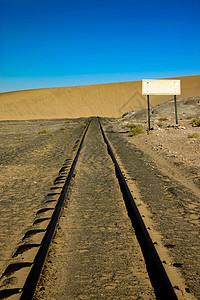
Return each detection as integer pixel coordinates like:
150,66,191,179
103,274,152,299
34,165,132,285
0,119,85,274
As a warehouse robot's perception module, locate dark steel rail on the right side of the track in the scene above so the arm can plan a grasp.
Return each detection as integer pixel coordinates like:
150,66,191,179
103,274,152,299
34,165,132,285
98,118,178,300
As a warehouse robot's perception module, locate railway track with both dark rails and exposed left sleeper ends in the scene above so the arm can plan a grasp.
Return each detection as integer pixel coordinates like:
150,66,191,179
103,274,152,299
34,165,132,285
0,119,177,299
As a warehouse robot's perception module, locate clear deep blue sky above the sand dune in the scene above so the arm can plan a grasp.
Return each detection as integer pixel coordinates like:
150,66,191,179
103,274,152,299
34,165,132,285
0,0,200,92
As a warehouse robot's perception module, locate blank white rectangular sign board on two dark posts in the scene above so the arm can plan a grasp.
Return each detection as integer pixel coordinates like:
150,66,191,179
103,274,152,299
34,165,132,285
142,79,181,95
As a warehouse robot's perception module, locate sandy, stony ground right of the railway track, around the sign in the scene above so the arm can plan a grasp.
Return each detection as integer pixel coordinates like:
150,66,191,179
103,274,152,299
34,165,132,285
104,98,200,299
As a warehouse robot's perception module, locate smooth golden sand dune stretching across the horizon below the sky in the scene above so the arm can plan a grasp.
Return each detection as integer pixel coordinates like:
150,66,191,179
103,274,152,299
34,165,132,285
0,75,200,120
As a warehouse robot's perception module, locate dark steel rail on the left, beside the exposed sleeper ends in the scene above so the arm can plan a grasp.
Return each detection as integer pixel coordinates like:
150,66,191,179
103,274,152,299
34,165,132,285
20,123,90,300
